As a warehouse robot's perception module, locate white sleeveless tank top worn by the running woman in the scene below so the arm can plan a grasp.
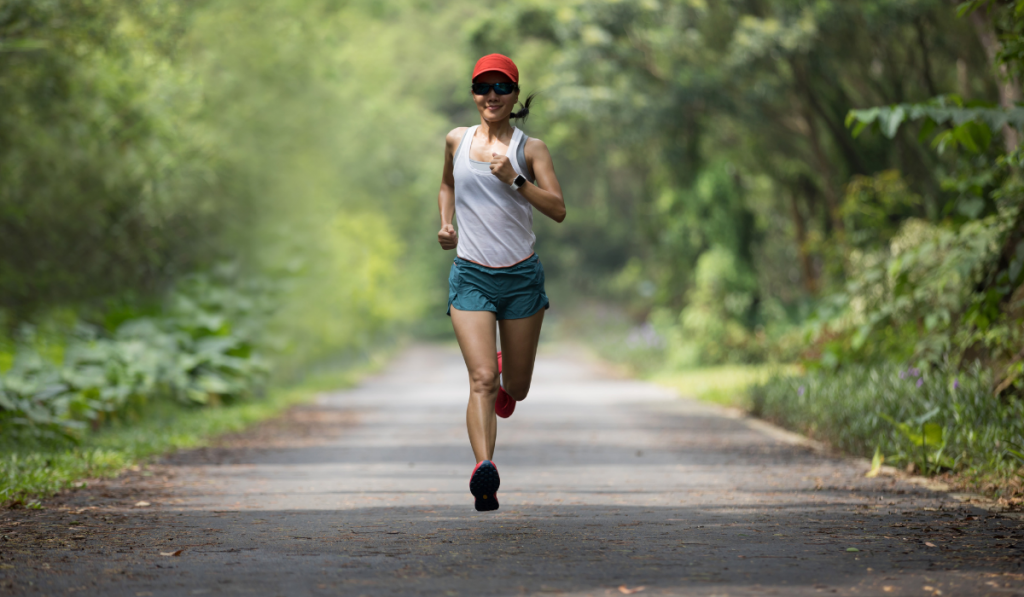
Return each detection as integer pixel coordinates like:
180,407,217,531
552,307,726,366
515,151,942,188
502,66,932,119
453,125,537,267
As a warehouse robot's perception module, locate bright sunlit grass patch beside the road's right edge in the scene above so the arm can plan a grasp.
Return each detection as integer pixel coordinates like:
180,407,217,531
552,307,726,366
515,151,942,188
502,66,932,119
649,365,792,411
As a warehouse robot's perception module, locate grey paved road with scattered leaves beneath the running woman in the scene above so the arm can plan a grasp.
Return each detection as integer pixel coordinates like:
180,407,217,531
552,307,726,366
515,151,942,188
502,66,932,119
0,346,1024,597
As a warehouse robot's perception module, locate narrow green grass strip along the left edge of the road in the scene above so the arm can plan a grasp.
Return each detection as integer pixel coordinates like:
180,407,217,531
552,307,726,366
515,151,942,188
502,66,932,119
0,352,386,507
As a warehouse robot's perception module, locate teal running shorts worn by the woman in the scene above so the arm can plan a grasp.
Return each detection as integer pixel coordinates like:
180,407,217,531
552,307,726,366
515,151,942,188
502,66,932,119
447,255,551,319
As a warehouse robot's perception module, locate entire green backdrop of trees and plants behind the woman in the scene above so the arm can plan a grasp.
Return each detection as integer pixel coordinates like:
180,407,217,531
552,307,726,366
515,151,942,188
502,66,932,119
0,0,1024,496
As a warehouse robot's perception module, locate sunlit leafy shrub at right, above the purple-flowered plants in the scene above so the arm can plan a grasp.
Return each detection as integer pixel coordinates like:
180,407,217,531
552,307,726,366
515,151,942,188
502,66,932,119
810,216,1019,369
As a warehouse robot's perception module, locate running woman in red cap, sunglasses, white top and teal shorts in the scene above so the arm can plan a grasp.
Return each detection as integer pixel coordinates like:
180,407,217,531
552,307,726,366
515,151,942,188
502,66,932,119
437,54,565,511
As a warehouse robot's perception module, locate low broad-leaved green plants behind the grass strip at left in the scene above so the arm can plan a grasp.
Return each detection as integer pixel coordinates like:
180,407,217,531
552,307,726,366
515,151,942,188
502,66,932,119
0,278,267,437
